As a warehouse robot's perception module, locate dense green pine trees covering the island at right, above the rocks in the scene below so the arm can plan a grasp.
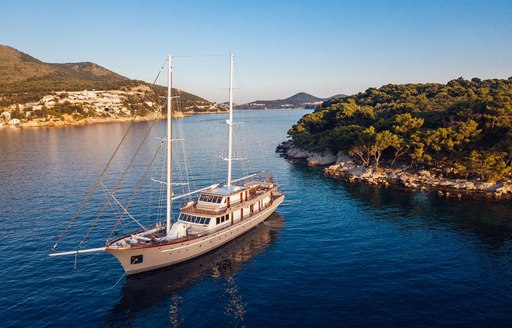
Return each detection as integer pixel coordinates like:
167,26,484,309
288,78,512,180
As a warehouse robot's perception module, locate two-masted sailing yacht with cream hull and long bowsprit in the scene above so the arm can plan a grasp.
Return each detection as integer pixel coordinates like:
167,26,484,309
50,55,285,275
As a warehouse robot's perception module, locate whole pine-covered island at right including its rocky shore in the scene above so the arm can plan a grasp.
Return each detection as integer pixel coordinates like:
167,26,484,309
278,78,512,199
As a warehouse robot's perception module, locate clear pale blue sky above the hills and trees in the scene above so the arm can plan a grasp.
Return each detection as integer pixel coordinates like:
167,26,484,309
0,0,512,103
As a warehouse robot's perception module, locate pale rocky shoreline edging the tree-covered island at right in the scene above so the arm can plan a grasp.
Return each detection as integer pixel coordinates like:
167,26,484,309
276,141,512,200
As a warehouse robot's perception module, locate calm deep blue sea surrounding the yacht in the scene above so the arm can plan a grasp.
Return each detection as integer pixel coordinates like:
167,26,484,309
0,111,512,327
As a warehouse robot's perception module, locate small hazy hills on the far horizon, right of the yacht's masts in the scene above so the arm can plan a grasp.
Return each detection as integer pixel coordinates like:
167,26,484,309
241,92,346,109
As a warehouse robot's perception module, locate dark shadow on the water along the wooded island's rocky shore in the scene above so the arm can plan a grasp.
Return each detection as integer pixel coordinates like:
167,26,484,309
335,181,512,249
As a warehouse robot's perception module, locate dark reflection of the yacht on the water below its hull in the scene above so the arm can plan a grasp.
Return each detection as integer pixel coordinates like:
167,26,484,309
107,213,284,325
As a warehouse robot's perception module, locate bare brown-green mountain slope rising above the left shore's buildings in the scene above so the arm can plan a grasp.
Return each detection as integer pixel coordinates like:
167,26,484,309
0,45,221,112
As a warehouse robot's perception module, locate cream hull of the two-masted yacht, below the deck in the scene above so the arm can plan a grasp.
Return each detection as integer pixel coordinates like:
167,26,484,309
105,195,284,275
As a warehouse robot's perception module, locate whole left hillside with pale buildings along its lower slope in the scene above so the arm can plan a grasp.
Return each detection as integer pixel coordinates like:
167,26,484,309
0,45,225,126
